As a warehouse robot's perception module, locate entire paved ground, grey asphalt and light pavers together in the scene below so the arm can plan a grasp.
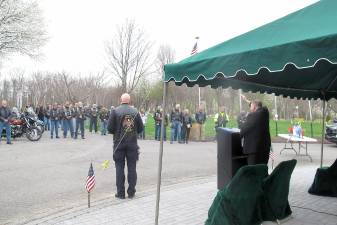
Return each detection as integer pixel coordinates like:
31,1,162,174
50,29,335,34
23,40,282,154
0,134,337,224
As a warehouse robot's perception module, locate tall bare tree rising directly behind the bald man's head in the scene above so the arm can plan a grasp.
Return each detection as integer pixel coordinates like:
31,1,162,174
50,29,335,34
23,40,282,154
105,20,153,93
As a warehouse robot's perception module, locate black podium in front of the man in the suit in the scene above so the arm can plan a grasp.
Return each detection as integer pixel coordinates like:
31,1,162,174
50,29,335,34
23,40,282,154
216,127,247,190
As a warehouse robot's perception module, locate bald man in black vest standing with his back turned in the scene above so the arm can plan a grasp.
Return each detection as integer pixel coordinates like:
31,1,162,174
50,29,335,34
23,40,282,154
108,93,143,199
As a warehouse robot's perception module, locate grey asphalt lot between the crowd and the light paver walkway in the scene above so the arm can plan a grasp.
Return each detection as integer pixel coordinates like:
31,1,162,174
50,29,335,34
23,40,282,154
0,133,337,224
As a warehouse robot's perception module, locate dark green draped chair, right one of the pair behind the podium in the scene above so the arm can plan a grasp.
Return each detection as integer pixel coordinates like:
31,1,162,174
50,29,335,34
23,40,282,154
262,159,297,221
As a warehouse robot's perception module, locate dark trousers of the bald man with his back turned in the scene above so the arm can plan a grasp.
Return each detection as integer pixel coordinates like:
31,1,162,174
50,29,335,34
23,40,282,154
113,143,139,196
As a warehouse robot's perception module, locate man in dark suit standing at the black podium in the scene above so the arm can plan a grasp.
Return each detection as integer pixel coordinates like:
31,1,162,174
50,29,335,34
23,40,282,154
240,101,271,165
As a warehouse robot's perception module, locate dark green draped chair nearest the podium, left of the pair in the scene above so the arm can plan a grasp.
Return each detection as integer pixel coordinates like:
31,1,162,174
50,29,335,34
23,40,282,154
205,165,268,225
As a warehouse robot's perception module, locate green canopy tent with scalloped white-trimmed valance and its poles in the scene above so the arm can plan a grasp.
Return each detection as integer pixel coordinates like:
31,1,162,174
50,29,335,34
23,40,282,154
156,0,337,224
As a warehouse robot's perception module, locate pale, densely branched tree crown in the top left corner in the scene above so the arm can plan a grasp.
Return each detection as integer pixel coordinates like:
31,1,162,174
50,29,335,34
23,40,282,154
0,0,47,57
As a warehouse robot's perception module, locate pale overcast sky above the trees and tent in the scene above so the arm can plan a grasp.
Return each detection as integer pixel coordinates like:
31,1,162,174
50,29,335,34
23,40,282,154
2,0,317,74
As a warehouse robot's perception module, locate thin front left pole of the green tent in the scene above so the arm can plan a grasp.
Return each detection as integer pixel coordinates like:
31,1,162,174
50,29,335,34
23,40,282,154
155,82,168,225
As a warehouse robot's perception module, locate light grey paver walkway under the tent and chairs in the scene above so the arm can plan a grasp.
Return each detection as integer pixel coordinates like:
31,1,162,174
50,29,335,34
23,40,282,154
24,166,337,225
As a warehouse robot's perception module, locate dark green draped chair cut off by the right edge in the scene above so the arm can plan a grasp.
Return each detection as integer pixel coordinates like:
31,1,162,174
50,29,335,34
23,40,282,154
308,159,337,197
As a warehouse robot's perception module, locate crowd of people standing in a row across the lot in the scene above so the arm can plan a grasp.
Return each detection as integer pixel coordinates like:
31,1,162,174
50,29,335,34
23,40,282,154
3,97,234,144
